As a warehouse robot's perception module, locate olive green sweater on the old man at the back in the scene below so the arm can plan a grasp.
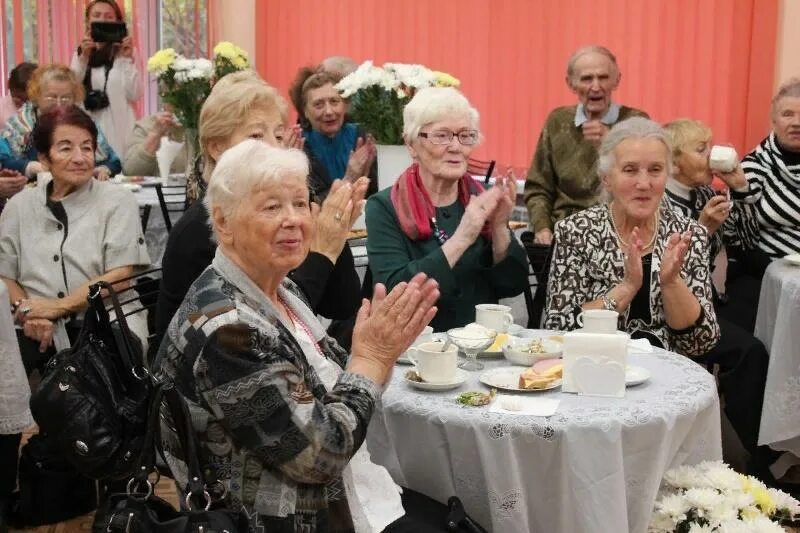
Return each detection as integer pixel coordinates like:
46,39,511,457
524,105,647,232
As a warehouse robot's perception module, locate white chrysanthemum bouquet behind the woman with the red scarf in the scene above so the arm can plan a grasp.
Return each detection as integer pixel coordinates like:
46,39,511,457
336,61,460,144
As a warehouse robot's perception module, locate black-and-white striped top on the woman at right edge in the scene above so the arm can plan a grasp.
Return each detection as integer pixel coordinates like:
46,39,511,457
742,132,800,258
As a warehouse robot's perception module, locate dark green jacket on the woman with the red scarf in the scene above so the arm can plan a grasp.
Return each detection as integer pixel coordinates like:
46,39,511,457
366,189,528,331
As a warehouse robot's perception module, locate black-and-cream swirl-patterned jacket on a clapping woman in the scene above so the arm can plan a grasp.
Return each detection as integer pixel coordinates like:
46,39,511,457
545,203,720,357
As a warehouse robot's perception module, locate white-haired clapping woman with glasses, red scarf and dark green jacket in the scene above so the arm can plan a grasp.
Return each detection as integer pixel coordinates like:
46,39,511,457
366,88,528,331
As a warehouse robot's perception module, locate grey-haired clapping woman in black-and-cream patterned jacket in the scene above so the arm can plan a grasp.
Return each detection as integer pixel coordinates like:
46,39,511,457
545,117,719,356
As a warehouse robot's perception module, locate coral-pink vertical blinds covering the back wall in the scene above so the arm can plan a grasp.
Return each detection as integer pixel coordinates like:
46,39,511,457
255,0,778,166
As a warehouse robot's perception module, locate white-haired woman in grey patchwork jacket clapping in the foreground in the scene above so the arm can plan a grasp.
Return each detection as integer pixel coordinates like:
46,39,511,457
159,140,438,531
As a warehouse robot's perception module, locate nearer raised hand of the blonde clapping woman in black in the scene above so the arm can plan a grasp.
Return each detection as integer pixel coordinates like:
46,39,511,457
311,180,354,263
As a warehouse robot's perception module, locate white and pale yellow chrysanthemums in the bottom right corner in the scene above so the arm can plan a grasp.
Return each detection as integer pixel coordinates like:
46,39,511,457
648,461,800,533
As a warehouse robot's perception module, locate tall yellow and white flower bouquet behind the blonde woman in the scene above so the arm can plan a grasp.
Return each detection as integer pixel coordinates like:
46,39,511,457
147,41,249,202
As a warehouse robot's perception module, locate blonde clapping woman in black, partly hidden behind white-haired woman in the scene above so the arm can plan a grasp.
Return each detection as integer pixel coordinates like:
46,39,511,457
156,71,367,338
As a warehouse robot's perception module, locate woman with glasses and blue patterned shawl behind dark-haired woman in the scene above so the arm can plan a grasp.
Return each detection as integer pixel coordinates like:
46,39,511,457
0,64,122,181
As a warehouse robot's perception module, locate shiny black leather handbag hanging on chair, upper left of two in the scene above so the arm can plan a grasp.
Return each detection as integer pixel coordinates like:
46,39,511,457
30,282,157,479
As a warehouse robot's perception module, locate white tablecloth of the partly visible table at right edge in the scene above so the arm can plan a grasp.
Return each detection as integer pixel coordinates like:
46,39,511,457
755,259,800,456
